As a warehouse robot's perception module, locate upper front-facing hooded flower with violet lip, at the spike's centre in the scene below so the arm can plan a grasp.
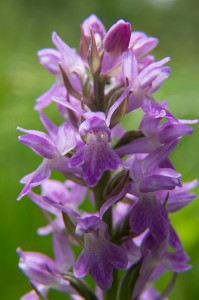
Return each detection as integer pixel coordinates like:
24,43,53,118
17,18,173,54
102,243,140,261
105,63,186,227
69,113,121,187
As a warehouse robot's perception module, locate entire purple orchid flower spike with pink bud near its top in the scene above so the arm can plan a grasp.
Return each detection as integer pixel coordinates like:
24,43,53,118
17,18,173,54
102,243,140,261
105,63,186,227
17,15,198,300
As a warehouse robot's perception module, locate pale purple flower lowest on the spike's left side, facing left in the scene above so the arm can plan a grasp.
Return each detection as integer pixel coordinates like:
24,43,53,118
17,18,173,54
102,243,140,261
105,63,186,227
17,232,76,299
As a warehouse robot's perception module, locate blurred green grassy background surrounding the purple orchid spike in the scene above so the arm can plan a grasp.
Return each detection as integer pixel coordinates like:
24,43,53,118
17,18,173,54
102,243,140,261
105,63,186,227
0,0,199,300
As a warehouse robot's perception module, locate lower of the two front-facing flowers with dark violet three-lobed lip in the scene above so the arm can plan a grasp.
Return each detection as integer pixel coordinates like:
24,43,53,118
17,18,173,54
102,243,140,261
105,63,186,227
73,216,127,290
